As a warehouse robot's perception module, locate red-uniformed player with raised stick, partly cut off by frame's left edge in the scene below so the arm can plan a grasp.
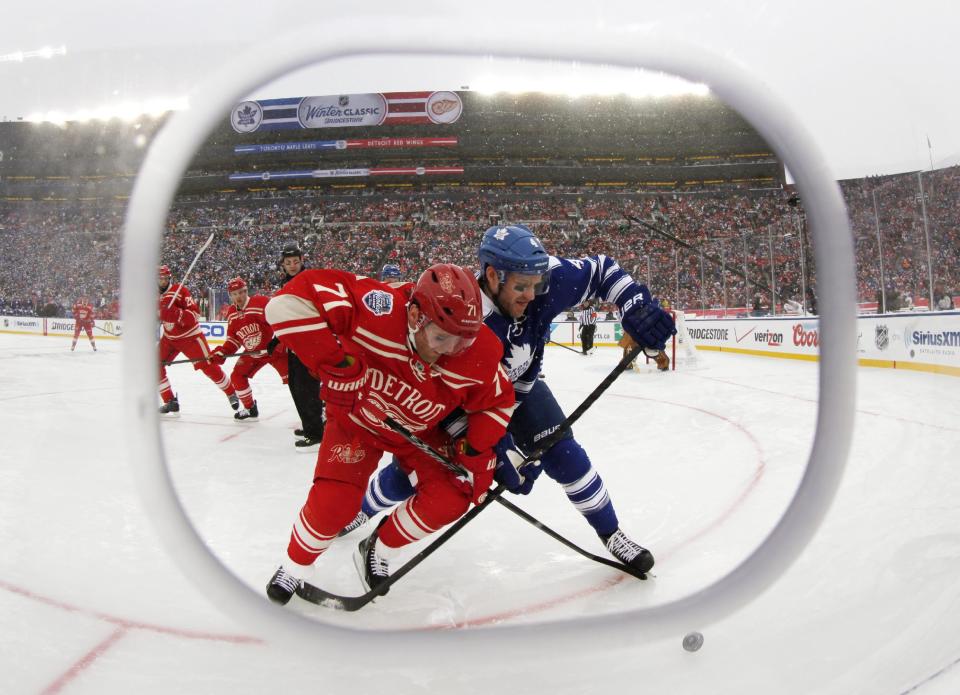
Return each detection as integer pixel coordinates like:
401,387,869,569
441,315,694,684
157,265,240,413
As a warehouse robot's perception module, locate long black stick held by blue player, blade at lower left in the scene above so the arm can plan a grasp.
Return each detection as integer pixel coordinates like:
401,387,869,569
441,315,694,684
297,346,641,611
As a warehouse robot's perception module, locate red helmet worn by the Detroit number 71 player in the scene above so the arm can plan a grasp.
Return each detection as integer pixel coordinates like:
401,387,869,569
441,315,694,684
410,263,483,350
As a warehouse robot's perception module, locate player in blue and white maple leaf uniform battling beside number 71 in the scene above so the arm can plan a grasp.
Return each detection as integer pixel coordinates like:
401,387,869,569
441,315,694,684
344,224,675,572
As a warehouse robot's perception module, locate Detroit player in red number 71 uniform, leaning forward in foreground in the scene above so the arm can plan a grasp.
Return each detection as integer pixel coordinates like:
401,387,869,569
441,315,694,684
267,264,514,604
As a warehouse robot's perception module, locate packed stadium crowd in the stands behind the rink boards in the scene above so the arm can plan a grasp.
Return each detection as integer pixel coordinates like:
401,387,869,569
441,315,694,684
0,167,960,318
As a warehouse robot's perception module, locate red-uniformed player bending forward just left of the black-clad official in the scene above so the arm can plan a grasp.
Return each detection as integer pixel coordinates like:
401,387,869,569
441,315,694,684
210,278,287,420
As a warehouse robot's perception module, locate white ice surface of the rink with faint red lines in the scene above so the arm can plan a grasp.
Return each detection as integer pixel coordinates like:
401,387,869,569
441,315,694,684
0,335,960,695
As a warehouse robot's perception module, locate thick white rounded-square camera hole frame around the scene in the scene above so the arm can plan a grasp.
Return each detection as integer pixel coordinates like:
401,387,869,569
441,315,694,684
121,18,856,666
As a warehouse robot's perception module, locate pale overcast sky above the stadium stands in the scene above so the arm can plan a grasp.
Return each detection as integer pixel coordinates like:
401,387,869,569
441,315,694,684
0,0,960,178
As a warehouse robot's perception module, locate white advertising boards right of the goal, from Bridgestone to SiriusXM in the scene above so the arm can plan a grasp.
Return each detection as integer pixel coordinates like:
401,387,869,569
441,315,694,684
687,311,960,376
